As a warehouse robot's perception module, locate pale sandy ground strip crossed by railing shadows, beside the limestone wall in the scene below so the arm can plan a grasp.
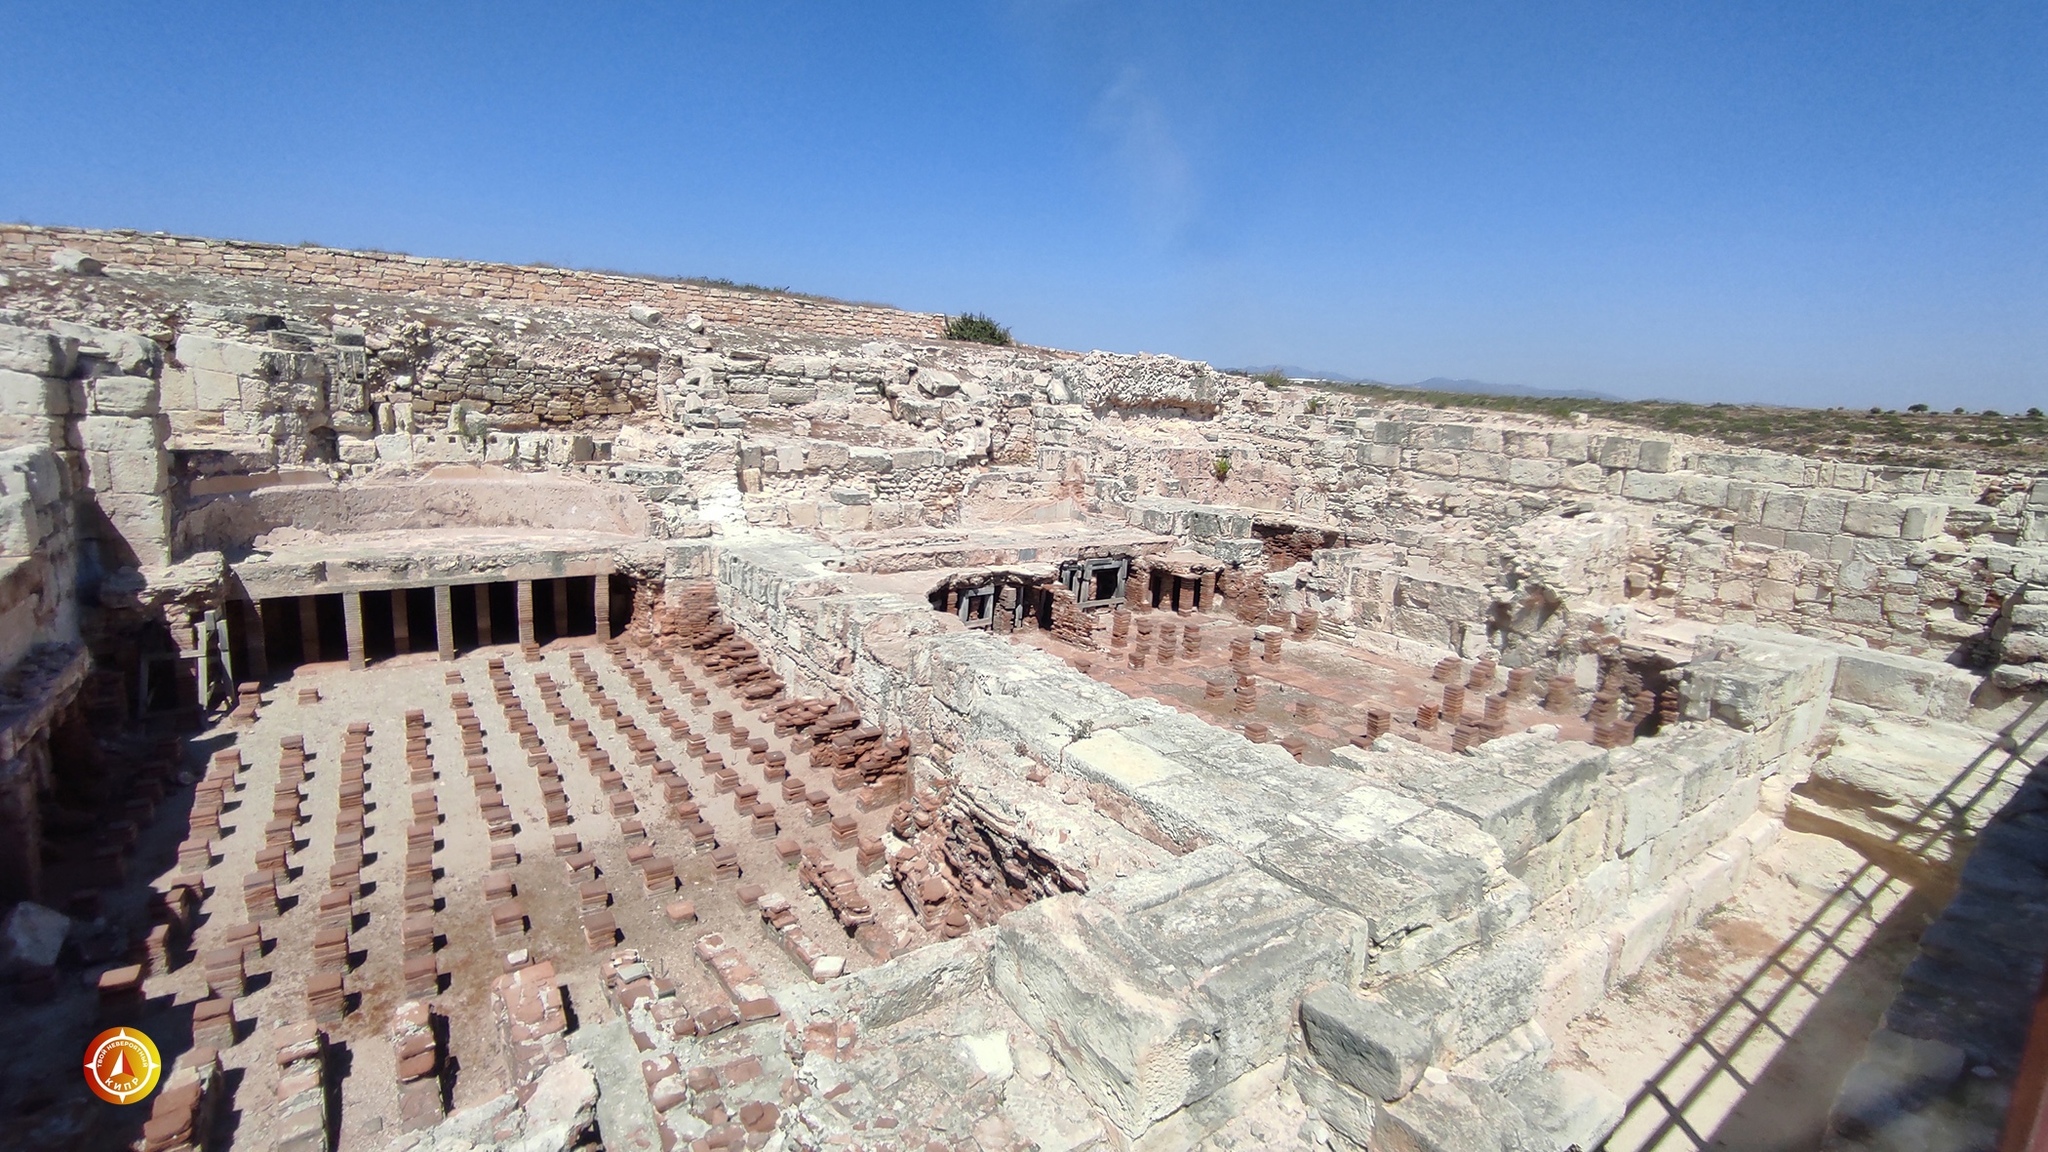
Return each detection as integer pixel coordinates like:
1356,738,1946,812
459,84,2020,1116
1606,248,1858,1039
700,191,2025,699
1554,830,1937,1152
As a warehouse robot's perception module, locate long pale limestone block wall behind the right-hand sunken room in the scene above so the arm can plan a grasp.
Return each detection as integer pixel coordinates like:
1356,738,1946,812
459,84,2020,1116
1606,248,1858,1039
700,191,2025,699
1073,402,2048,660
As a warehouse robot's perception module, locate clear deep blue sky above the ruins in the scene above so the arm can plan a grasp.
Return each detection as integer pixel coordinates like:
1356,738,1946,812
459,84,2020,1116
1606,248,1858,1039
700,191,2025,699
0,0,2048,410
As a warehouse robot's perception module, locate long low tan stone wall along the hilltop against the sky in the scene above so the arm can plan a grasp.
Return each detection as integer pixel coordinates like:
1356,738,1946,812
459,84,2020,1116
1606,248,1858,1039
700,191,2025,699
0,223,944,340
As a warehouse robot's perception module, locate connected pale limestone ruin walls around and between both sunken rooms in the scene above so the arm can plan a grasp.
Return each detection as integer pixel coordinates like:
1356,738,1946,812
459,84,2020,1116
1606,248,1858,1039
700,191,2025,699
0,230,2048,1146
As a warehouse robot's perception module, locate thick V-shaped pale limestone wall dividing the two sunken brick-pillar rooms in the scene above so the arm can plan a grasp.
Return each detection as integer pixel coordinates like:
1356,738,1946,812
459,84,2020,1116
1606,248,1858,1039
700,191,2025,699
696,543,1892,1146
